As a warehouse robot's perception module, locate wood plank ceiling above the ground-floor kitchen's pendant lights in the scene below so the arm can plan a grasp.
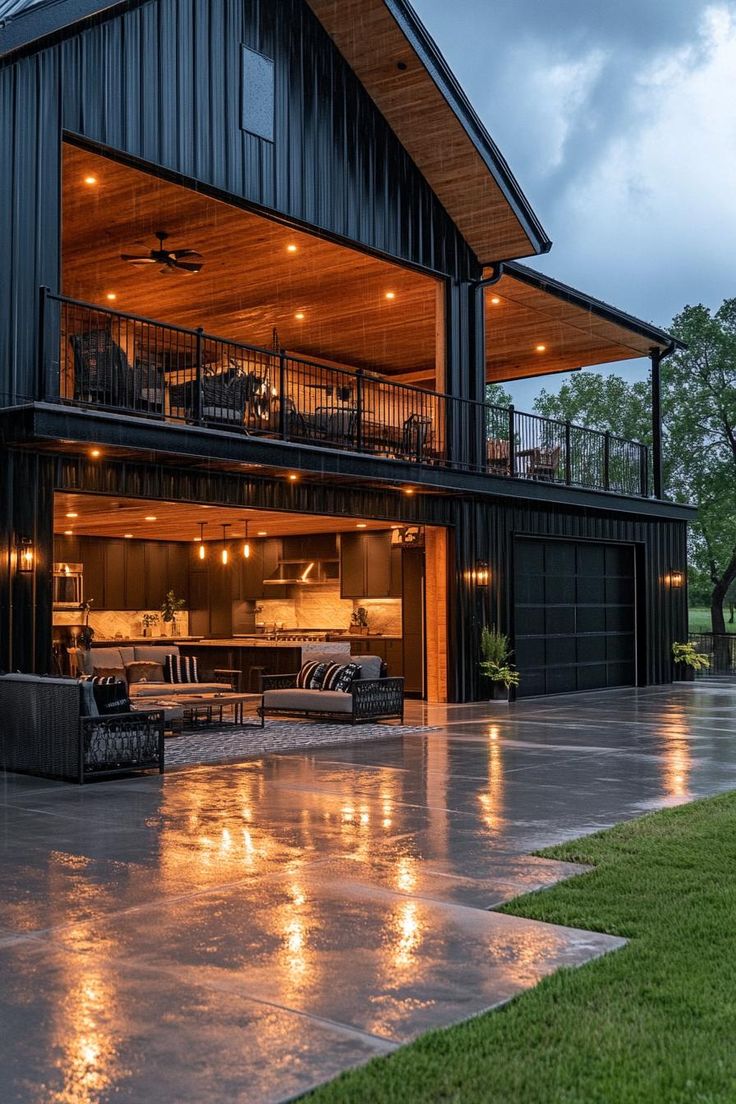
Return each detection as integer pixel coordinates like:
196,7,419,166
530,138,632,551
54,491,391,542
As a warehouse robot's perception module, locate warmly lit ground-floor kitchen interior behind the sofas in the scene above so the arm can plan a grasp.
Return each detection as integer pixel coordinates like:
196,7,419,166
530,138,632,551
53,493,447,701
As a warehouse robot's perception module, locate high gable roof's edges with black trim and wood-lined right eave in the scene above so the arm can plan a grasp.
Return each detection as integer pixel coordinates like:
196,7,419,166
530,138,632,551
0,0,552,264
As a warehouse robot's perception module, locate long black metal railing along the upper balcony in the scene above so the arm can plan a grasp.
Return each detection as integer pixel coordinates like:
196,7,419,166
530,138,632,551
39,290,649,497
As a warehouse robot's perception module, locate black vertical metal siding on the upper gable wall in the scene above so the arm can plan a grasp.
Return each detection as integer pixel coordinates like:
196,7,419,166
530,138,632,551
0,0,482,396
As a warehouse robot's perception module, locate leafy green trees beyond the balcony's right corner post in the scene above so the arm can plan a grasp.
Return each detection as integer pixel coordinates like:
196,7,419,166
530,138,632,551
535,299,736,633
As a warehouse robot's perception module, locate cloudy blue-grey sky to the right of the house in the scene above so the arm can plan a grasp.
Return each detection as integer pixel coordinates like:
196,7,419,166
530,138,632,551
414,0,736,404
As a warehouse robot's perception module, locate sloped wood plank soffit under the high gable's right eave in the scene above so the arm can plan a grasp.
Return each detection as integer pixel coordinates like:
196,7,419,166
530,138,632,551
308,0,537,262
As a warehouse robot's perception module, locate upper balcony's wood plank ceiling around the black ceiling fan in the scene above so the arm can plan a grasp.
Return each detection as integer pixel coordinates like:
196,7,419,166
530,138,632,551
62,144,439,380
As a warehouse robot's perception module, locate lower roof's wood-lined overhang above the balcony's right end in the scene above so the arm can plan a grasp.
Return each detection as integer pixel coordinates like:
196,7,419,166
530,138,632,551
486,263,683,381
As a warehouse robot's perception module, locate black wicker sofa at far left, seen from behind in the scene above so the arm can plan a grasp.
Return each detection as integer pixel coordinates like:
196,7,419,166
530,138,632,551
0,675,163,784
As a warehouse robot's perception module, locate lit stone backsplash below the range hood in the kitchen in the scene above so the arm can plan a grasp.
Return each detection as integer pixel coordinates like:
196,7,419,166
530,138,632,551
256,587,402,636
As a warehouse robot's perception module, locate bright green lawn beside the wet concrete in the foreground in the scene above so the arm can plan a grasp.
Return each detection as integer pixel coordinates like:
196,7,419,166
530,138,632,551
306,794,736,1104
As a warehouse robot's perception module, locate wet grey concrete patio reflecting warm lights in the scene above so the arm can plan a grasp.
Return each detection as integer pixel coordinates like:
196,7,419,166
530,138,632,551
0,683,736,1104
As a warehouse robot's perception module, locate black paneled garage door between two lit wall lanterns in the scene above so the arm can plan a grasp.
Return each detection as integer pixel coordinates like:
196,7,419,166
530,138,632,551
514,539,637,697
